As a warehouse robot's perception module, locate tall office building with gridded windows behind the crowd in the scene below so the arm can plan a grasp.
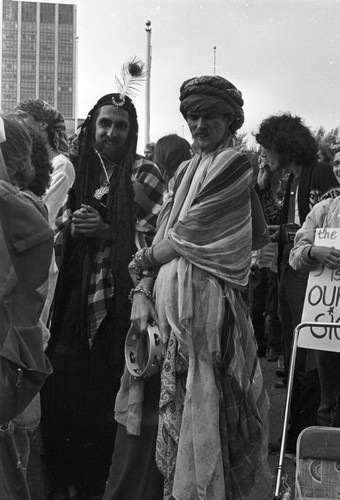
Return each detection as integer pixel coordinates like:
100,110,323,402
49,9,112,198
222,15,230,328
0,0,77,120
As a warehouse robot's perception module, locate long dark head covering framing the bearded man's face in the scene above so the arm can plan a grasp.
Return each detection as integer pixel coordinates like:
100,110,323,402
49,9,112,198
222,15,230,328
70,94,138,310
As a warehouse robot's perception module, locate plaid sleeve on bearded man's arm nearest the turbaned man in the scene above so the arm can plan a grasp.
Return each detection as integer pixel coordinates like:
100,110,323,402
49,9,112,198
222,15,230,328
132,157,166,241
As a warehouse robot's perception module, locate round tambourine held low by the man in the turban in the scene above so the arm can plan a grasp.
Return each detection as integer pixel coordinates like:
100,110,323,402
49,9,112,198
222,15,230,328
125,325,163,378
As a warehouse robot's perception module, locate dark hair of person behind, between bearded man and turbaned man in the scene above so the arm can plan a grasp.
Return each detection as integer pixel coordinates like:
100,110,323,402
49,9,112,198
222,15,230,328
154,134,192,181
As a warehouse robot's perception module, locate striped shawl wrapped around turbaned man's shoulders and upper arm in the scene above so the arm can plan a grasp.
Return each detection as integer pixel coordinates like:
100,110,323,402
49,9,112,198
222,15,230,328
154,148,252,287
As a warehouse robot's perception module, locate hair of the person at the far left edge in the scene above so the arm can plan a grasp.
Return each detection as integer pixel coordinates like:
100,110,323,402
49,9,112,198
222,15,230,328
1,112,32,186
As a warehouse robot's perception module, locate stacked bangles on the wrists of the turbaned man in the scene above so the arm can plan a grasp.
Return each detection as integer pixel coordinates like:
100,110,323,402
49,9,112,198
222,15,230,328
129,247,160,302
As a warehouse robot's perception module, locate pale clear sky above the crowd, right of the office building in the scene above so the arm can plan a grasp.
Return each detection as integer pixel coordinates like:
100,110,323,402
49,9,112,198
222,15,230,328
77,0,340,152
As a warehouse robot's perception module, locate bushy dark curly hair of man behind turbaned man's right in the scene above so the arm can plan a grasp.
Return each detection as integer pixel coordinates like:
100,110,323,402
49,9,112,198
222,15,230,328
255,113,318,166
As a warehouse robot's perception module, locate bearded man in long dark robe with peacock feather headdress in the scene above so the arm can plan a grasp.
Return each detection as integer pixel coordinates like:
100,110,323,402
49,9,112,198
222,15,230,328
42,59,165,498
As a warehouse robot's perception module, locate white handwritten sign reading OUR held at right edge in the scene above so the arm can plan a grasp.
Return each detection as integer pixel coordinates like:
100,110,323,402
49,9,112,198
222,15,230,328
299,228,340,351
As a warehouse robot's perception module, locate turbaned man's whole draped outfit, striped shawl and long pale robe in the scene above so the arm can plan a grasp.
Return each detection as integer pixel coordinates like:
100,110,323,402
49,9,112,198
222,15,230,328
154,149,268,500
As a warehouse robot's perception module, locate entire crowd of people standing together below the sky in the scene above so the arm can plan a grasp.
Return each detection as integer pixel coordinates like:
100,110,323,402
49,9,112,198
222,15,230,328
0,61,340,500
